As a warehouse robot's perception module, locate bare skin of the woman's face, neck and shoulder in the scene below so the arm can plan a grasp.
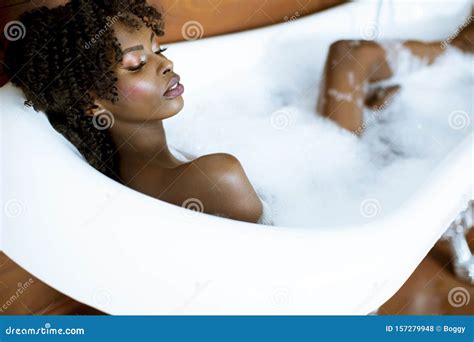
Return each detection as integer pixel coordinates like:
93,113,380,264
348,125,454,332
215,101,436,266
89,22,262,222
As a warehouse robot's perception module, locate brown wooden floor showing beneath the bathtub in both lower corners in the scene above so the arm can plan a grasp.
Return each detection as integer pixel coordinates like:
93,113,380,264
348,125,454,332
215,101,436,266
0,229,474,315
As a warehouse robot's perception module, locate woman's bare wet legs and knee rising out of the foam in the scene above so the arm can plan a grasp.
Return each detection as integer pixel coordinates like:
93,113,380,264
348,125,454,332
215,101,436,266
317,18,474,135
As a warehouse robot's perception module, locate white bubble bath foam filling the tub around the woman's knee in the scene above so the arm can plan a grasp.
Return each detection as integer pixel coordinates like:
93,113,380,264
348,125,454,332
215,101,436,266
165,41,474,226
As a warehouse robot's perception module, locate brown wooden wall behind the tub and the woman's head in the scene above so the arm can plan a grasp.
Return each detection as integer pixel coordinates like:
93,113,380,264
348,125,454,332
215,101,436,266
0,0,346,86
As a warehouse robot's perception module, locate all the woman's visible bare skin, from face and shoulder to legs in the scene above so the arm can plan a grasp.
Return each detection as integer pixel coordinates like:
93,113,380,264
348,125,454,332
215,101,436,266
83,14,474,222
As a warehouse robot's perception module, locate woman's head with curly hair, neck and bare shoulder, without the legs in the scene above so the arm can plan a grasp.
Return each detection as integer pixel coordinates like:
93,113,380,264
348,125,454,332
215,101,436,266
5,0,262,222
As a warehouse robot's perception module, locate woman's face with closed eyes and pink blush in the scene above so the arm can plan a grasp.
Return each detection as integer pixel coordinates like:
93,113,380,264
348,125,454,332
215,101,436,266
96,22,184,122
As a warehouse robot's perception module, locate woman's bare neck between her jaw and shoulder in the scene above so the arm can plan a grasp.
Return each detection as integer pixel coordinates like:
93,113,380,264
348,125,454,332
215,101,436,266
109,120,179,169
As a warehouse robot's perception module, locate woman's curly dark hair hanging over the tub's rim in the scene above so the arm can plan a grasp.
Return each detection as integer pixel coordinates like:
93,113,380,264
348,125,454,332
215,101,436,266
5,0,164,181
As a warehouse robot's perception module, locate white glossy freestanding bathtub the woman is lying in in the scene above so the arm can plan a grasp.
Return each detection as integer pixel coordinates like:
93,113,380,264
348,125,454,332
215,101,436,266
0,2,473,314
